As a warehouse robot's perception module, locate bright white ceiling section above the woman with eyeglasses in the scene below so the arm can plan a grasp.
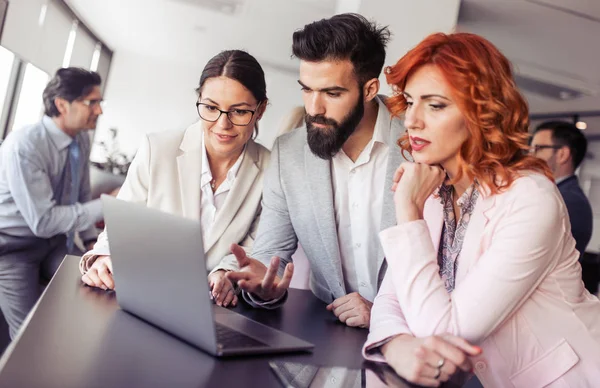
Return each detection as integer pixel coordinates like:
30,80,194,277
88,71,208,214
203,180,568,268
67,0,336,73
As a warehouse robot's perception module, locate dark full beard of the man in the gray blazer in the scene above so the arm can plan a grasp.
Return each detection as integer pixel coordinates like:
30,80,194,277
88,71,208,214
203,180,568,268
304,91,365,160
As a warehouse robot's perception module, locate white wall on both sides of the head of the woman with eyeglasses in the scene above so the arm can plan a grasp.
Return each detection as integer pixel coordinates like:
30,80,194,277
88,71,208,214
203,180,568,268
92,52,302,161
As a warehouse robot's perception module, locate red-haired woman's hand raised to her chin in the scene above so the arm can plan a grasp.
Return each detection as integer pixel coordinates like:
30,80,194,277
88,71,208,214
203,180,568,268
392,162,446,224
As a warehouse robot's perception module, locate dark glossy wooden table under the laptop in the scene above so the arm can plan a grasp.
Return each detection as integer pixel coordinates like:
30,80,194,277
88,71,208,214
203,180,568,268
0,256,367,388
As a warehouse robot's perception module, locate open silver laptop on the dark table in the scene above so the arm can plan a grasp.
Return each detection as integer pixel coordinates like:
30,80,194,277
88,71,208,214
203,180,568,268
102,195,314,356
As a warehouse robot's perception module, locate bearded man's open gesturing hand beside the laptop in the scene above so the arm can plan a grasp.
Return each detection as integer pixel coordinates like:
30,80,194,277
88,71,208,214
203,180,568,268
226,244,294,301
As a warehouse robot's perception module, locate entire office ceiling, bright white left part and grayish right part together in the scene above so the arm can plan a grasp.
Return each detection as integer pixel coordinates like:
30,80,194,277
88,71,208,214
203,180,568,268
66,0,600,134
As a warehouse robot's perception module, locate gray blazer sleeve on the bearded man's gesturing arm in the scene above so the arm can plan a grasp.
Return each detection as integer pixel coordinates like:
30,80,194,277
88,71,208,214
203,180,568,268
252,139,298,276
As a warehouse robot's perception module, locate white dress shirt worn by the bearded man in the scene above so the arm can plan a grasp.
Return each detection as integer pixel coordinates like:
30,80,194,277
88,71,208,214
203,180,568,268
331,99,390,302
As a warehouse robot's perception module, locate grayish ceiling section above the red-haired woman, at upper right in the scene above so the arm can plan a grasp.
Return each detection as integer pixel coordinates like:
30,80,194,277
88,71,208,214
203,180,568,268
457,0,600,134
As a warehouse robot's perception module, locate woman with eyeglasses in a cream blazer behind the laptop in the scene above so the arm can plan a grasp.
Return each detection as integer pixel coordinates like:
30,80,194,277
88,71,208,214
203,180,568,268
80,50,270,306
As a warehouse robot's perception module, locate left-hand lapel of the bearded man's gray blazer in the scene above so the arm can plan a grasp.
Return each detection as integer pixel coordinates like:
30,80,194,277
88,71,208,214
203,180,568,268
304,145,346,294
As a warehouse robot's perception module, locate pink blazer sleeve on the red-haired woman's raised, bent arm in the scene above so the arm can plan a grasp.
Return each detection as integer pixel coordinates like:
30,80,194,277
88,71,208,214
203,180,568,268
380,190,568,344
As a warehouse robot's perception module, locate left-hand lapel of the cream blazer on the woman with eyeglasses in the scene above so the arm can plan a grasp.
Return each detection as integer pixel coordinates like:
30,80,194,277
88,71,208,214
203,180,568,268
177,124,202,220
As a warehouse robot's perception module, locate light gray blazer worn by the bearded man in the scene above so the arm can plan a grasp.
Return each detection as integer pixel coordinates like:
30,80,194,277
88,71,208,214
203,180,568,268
244,101,404,307
